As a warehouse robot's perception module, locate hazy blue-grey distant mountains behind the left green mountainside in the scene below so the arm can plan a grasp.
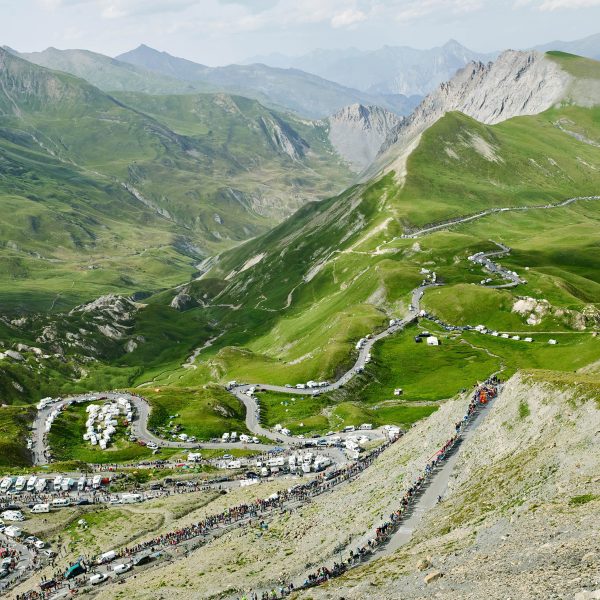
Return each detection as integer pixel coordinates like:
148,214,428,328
8,45,420,118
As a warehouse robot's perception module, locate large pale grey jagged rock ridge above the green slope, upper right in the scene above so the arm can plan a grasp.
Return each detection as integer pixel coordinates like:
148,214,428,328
371,50,572,174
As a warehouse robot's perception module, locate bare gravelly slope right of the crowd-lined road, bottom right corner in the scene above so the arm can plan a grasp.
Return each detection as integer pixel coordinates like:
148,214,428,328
299,374,600,600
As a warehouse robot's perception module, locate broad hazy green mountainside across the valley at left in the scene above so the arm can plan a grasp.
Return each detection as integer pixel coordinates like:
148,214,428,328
0,50,351,310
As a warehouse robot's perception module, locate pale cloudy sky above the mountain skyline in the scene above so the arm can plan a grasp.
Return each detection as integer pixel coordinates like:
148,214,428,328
0,0,600,66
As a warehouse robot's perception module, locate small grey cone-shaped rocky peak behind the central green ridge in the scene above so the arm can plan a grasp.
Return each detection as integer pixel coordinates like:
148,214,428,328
329,104,404,172
